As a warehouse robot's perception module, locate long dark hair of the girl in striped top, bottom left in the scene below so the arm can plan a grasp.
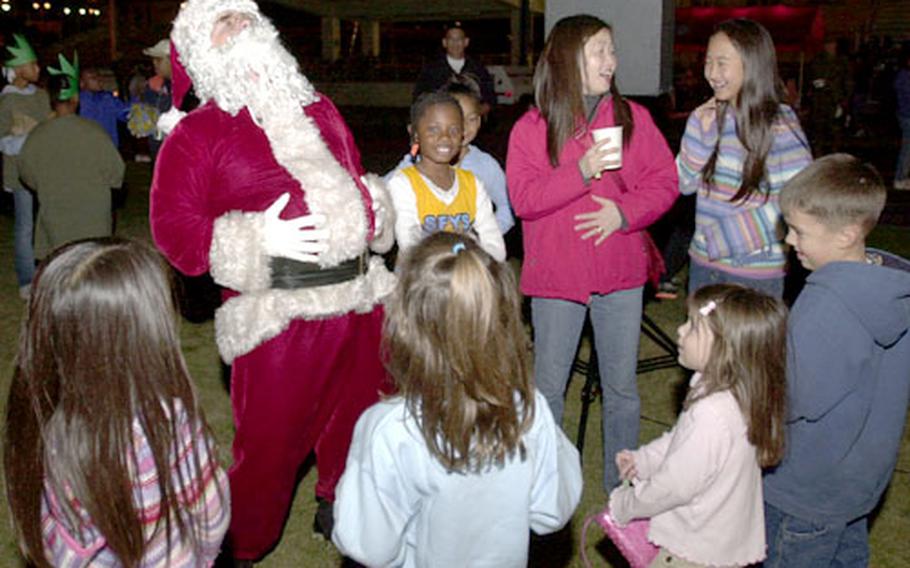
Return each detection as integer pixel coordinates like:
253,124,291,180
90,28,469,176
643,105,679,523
3,239,221,567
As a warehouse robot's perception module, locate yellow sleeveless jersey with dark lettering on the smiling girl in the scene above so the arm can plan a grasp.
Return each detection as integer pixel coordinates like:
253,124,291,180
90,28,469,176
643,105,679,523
401,166,477,235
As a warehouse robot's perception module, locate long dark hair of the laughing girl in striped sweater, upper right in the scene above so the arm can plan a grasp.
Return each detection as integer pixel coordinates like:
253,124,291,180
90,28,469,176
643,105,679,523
702,18,784,202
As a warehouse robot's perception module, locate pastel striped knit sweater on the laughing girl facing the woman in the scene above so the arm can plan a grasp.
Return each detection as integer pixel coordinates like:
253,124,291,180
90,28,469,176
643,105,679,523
676,105,812,279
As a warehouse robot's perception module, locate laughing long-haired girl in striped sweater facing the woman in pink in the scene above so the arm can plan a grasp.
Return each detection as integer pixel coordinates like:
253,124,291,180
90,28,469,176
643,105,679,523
676,19,812,297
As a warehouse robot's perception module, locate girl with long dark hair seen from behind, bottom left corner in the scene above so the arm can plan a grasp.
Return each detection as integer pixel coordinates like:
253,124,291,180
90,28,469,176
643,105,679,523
3,239,230,567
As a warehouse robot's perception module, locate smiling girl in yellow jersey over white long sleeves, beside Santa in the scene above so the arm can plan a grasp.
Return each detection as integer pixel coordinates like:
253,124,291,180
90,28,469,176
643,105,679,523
389,93,506,262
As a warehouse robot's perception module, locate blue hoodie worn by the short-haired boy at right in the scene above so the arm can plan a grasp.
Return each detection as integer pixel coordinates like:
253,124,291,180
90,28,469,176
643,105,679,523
764,253,910,522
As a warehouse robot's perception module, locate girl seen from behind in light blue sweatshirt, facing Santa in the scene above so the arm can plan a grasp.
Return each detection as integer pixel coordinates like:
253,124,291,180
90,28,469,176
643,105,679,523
333,233,582,566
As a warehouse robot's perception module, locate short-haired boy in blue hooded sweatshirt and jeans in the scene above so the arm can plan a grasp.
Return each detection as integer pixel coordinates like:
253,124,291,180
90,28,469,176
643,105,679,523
764,154,910,567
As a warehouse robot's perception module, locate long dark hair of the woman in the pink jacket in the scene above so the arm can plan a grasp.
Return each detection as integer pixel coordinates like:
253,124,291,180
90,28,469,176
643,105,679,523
534,14,634,167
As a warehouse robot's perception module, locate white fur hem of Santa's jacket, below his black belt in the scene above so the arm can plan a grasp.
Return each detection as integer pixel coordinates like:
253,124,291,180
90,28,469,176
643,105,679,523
215,257,396,364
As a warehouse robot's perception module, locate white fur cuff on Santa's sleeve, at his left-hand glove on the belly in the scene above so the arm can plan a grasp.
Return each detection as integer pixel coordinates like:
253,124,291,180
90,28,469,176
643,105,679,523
209,211,271,292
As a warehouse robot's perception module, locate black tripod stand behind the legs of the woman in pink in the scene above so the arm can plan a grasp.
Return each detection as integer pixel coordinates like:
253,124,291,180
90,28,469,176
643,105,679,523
572,312,678,454
